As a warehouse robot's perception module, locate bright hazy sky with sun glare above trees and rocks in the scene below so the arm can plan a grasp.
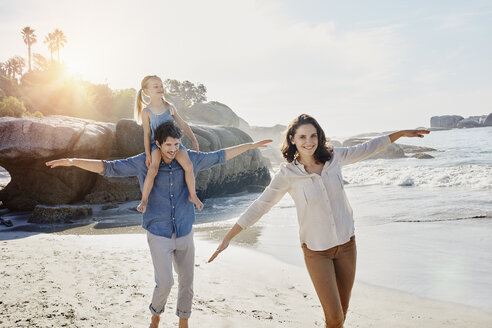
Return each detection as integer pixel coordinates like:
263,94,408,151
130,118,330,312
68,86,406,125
0,0,492,136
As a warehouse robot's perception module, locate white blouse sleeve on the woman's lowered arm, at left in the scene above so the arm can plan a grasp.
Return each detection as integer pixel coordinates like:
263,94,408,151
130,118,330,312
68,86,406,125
236,167,290,229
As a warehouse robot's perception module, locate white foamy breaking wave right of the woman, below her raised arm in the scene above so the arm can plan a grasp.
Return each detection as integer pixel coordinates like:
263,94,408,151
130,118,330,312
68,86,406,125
343,163,492,189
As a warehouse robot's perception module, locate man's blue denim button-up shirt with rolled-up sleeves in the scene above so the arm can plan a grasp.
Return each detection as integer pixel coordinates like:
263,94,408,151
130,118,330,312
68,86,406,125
101,150,225,238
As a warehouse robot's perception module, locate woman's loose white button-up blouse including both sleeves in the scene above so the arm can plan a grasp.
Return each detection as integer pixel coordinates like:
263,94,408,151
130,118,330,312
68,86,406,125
237,136,391,251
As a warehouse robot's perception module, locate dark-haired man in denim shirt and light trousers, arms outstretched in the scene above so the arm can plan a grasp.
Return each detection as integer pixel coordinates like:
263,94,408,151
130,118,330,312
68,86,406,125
46,121,271,328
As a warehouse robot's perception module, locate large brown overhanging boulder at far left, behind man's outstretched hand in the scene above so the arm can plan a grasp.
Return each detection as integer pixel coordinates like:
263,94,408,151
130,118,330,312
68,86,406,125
0,116,114,210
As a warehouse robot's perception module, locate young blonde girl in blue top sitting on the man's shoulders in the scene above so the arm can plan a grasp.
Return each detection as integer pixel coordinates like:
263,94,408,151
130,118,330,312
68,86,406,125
135,75,203,213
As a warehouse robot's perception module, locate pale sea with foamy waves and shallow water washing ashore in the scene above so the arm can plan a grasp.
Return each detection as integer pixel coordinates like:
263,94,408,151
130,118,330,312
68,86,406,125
197,127,492,312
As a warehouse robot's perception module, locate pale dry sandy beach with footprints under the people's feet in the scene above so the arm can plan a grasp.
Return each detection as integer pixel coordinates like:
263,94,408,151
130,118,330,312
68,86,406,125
0,231,492,328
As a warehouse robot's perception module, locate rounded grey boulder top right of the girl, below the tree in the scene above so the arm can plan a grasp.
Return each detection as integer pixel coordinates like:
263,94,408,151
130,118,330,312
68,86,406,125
184,101,240,127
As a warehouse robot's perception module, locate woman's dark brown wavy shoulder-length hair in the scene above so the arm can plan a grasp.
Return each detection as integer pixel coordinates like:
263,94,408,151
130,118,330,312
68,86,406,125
281,114,333,164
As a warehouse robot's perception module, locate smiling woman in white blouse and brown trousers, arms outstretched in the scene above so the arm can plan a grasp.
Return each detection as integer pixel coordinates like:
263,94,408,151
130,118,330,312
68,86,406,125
209,114,429,328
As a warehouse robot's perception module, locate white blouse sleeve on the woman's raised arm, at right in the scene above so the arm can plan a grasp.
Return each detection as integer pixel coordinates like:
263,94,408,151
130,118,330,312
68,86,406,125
334,136,391,165
